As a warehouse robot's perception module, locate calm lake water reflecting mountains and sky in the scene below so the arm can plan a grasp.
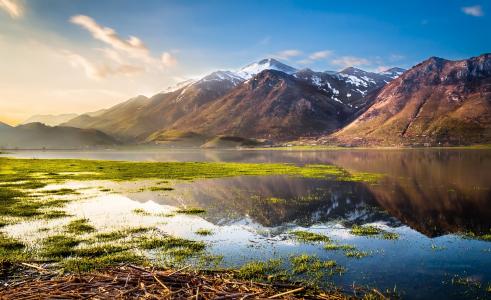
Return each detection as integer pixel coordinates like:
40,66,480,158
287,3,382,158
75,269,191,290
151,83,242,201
2,150,491,299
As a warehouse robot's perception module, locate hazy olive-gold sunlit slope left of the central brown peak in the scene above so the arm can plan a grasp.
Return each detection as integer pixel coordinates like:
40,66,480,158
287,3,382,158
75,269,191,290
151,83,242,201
64,71,241,141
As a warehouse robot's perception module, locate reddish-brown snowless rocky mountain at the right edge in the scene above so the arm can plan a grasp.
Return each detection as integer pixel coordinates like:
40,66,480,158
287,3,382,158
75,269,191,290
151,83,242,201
330,54,491,145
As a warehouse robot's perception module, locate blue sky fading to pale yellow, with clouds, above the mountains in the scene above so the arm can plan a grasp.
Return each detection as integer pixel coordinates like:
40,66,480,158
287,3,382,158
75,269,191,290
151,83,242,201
0,0,491,125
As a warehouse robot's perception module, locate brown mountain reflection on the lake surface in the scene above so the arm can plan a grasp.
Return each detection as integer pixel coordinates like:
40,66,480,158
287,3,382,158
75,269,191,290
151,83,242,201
4,149,491,237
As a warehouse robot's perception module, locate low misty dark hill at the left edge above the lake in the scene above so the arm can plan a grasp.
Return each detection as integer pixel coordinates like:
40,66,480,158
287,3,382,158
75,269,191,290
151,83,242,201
0,123,119,149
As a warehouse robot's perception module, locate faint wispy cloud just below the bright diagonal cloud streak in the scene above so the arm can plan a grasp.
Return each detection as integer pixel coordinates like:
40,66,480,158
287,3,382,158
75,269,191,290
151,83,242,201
62,50,144,80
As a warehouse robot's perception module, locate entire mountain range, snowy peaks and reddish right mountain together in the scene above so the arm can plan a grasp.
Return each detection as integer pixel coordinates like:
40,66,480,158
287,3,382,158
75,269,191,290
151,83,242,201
17,54,491,146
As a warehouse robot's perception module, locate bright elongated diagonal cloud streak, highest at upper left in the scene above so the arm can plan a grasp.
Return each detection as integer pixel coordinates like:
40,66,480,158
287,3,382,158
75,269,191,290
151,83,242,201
70,15,150,60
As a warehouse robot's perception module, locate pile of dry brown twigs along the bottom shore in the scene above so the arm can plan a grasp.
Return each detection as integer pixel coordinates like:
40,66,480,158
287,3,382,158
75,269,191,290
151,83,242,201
0,265,351,300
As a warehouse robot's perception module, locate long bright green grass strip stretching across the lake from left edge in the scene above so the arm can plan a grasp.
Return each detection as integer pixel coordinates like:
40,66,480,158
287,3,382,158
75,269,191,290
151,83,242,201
0,157,380,187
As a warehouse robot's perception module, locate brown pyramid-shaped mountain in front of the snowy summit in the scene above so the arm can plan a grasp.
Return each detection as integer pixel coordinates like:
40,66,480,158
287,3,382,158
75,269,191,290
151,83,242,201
173,70,352,140
